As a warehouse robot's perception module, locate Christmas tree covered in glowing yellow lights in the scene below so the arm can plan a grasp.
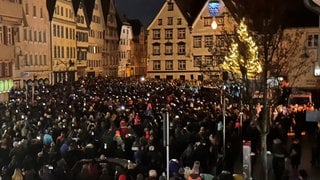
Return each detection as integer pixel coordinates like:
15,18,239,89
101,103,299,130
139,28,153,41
222,19,262,80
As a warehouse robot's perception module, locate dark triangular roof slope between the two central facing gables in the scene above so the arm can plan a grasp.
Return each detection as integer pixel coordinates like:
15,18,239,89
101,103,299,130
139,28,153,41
175,0,207,25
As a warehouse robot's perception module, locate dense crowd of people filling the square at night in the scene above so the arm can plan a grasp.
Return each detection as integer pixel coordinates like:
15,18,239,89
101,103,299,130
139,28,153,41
0,77,316,180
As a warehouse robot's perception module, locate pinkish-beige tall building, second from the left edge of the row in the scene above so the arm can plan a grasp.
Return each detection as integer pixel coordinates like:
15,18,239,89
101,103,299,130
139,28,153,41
13,0,51,90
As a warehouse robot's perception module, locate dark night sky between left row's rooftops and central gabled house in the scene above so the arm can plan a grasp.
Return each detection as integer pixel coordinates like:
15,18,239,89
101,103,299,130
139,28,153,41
115,0,165,27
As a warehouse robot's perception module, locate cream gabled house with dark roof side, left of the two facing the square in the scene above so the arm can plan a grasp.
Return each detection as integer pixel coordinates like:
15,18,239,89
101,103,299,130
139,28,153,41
147,0,207,80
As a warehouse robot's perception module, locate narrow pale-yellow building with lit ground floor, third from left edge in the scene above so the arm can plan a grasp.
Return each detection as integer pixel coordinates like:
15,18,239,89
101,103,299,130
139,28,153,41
47,0,77,84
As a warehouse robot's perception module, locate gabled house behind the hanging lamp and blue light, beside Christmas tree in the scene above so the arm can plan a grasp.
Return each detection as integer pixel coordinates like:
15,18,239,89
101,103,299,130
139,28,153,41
191,1,236,81
